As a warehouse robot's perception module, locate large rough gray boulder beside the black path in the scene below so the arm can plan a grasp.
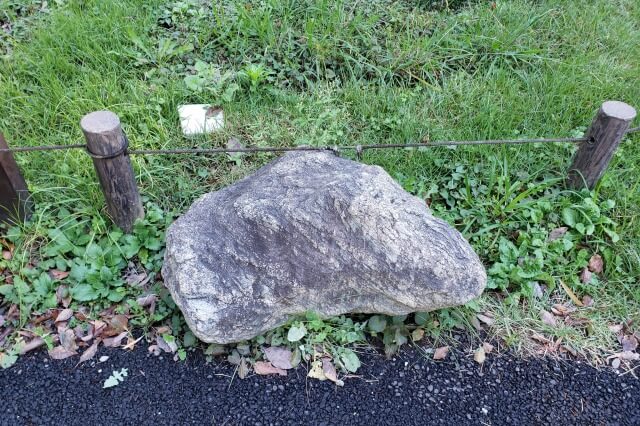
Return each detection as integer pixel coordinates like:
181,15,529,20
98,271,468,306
162,152,486,344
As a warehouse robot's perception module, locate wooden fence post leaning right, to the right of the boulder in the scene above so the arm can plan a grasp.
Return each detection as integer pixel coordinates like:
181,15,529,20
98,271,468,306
567,101,636,189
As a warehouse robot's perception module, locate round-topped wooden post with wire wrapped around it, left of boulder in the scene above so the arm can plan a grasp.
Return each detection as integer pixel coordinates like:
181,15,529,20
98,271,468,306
80,111,144,232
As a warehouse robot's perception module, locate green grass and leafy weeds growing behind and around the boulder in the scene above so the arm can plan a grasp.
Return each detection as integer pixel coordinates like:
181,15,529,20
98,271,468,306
0,0,640,370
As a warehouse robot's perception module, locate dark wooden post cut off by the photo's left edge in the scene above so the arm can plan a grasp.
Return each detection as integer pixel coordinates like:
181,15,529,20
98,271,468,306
0,133,31,223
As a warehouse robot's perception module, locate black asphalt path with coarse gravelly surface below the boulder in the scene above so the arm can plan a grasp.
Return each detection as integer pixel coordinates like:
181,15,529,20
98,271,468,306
0,348,640,426
